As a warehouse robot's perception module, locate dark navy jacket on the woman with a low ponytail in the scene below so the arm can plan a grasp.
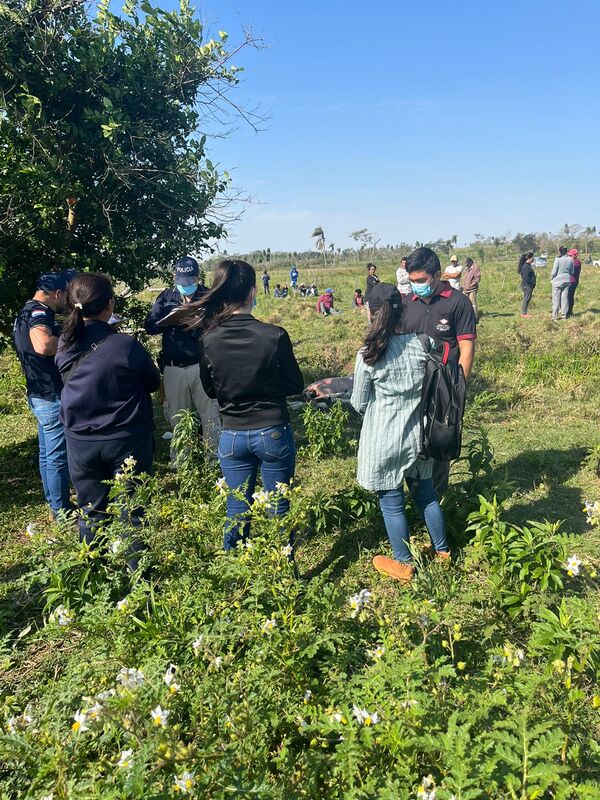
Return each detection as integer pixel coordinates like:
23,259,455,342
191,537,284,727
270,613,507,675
56,320,160,440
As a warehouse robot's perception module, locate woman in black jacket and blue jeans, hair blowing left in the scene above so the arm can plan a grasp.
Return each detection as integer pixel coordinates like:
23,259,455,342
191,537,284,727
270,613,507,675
189,260,304,550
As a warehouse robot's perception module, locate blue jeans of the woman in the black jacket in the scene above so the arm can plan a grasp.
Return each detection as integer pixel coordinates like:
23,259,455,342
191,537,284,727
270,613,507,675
218,423,296,550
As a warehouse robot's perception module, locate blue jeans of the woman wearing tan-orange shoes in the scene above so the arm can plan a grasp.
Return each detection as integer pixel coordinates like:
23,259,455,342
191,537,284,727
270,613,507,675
377,478,450,564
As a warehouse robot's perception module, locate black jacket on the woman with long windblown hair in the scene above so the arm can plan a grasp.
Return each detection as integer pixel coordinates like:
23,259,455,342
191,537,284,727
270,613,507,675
200,314,304,430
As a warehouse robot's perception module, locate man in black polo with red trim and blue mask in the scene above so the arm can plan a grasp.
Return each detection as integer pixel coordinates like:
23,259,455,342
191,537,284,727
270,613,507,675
402,247,477,497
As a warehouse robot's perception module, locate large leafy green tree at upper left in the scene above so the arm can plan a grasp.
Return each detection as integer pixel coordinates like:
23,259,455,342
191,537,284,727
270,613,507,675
0,0,250,328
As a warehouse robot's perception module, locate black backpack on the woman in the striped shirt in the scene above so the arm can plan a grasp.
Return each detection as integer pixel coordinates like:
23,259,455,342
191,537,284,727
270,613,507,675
418,333,466,461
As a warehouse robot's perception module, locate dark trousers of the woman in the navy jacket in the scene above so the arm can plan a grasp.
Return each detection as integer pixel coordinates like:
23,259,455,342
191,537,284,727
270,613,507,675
67,431,154,549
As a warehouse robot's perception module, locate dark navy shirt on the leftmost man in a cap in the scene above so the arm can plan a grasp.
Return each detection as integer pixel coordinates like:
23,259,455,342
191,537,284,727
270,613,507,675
13,300,62,400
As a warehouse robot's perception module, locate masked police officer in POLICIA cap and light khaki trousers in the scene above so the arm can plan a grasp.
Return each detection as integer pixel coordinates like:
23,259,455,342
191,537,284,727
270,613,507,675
144,256,221,451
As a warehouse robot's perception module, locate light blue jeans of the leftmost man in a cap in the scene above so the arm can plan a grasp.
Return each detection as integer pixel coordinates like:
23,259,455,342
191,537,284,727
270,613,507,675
28,396,72,514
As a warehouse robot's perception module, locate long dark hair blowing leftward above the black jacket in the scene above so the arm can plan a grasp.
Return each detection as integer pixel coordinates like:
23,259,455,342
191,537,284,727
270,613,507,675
187,259,256,330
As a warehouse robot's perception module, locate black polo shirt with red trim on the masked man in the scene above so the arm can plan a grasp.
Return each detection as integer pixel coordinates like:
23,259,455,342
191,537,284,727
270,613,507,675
402,281,477,362
